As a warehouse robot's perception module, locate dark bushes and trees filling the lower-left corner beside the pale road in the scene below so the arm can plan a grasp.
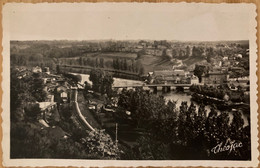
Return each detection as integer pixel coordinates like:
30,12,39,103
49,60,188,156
10,69,121,159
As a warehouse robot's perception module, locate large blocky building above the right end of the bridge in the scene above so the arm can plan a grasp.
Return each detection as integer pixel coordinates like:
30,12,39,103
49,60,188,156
201,71,229,84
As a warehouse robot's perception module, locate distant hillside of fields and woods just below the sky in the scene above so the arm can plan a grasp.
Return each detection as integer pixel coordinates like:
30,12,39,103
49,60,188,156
11,40,249,75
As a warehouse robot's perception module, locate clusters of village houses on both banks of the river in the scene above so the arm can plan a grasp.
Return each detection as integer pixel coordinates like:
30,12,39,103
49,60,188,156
13,48,249,133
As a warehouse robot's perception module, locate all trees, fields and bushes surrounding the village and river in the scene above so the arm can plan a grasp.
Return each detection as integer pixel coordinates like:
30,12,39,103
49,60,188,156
11,40,251,160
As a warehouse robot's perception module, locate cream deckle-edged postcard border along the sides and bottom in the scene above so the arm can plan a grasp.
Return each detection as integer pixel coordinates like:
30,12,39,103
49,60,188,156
2,3,259,167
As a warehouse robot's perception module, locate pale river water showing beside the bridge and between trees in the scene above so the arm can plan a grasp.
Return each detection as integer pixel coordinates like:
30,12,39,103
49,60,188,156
72,73,248,126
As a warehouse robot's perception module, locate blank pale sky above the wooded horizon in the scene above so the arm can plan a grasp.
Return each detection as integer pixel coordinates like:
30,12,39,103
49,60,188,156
3,3,252,41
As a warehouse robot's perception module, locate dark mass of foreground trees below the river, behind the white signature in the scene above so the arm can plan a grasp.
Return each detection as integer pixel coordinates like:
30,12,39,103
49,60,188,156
117,90,251,160
